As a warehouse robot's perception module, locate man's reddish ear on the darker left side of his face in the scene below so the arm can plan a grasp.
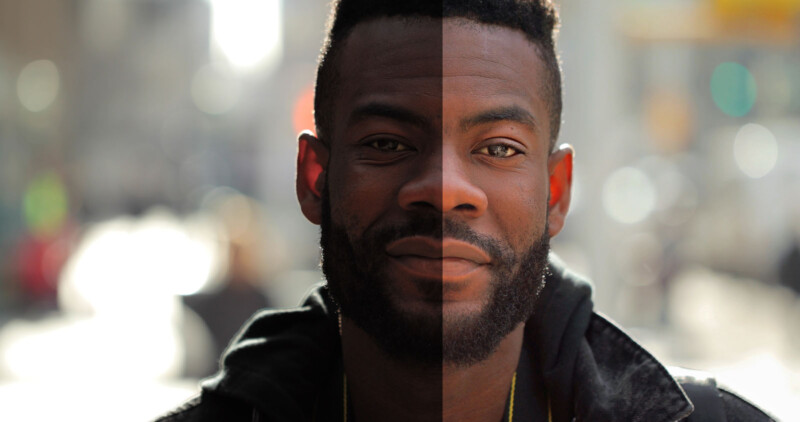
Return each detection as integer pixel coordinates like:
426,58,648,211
295,131,330,224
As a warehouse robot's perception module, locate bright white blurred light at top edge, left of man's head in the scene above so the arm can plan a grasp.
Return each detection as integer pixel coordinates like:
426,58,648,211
211,0,282,69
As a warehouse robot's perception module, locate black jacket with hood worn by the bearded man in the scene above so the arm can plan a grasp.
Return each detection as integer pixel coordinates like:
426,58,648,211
159,258,772,422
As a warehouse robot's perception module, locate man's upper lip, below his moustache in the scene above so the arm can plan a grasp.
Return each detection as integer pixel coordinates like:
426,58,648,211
386,236,491,265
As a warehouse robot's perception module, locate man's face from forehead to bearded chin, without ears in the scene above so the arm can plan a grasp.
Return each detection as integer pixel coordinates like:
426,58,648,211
310,19,557,364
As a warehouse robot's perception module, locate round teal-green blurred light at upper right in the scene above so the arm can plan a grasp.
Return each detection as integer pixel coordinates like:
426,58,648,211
711,62,757,117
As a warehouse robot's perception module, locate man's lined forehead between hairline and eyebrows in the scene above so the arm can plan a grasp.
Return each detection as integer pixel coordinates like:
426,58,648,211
334,18,548,137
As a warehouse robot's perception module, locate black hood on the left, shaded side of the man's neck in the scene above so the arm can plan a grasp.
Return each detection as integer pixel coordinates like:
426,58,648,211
202,284,341,421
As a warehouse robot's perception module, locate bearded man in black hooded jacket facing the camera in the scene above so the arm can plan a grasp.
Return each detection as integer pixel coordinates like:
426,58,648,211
158,0,769,422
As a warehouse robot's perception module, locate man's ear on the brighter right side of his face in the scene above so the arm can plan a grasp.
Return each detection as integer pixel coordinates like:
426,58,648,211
547,144,575,237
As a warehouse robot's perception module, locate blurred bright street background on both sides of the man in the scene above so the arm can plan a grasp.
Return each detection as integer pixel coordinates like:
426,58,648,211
0,0,800,421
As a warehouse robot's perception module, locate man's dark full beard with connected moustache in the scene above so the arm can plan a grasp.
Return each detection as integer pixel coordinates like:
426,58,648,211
320,186,550,366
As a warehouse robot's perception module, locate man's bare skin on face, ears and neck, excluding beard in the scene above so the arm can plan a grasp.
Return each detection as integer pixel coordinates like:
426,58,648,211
297,19,573,422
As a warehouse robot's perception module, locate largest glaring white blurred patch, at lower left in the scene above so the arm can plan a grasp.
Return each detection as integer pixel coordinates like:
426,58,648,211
0,210,226,380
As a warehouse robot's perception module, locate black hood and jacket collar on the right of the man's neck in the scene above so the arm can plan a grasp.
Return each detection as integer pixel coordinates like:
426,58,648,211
525,254,693,422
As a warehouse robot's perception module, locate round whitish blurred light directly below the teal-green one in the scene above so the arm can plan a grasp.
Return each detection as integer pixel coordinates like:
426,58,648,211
733,123,778,179
